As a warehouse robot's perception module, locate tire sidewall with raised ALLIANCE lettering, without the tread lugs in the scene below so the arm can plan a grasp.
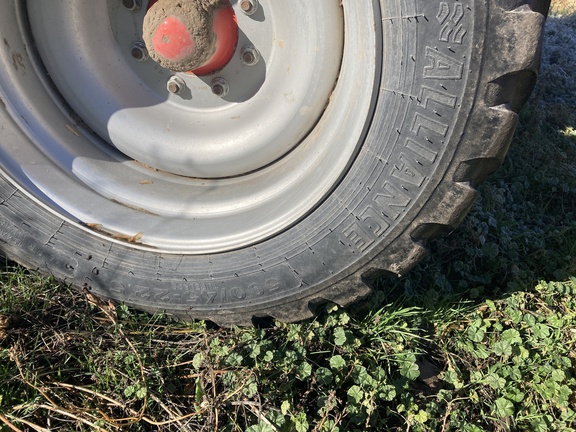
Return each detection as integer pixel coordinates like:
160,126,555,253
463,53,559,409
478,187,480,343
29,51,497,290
0,0,487,317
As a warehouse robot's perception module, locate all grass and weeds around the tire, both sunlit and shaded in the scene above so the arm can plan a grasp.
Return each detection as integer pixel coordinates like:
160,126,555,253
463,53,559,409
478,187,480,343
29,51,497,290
0,1,576,432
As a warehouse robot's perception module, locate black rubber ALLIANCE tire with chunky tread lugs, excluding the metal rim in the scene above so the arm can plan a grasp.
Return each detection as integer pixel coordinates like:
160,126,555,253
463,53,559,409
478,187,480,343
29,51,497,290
0,0,550,325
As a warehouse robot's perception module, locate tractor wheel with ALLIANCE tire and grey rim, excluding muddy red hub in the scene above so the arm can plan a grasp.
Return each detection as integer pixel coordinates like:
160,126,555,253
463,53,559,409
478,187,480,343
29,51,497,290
0,0,550,326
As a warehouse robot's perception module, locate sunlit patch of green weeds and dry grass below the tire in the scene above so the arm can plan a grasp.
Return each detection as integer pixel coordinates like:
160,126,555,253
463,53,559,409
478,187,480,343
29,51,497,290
0,264,576,431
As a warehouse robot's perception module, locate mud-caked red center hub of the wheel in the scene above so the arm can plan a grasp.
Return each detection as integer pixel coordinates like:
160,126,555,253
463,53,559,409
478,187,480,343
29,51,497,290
143,0,238,75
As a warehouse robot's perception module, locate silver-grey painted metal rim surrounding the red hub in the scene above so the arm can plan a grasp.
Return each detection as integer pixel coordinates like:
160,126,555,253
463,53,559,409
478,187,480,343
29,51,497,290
0,0,380,253
